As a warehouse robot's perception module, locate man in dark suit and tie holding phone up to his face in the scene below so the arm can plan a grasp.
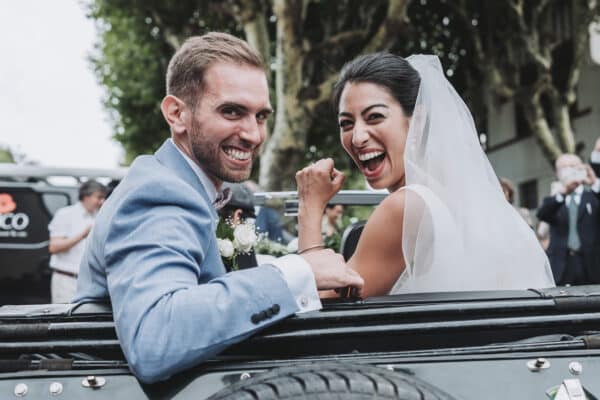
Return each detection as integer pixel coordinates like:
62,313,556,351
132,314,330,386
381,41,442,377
537,154,600,285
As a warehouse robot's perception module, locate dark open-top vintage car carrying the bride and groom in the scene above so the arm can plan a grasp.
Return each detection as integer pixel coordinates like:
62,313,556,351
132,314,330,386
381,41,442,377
0,193,600,400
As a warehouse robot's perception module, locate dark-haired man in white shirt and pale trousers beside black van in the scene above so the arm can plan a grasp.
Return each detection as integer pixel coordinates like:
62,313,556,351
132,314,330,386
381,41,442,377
48,180,107,303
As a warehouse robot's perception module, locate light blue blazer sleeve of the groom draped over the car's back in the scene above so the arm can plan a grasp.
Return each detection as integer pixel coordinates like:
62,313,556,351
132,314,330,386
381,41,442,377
104,185,298,383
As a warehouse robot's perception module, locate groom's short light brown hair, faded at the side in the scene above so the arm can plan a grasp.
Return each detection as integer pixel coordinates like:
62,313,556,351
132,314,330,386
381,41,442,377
167,32,264,108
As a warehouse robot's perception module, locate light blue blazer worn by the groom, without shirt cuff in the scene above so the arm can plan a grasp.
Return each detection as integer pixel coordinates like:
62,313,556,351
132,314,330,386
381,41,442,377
74,141,298,383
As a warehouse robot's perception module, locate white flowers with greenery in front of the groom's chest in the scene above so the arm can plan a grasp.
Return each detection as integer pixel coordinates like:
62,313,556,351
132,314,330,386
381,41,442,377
217,218,258,271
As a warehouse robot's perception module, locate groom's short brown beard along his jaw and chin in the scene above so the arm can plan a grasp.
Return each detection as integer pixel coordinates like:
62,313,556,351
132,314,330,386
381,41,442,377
189,120,254,182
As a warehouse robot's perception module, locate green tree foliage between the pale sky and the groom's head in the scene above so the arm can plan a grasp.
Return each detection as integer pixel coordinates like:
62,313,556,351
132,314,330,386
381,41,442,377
88,0,237,162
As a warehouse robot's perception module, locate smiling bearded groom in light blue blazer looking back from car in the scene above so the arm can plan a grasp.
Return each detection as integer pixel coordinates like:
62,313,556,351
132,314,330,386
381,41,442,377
74,33,363,382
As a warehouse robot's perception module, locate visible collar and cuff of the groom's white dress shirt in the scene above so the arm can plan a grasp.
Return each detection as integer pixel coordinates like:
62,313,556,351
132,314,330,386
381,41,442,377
169,139,322,313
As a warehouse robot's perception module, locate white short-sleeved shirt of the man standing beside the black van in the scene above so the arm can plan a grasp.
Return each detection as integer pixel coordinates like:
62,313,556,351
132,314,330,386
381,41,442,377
48,201,96,274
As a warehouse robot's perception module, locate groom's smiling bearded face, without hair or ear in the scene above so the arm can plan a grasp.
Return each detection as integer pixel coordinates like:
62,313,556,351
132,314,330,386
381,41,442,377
187,62,272,184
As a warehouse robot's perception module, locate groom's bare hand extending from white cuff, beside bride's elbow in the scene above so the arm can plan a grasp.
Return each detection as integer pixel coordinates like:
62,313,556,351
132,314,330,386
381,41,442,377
301,249,365,291
